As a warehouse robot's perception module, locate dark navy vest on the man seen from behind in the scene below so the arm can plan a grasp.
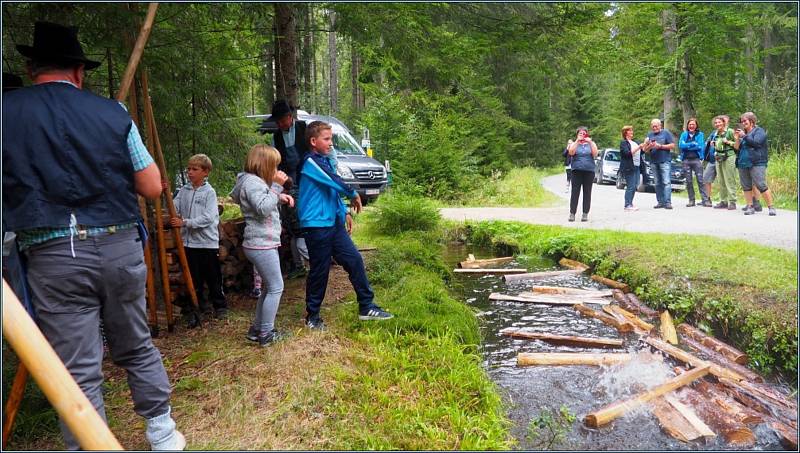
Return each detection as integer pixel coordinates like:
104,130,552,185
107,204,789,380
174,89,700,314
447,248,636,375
3,82,139,231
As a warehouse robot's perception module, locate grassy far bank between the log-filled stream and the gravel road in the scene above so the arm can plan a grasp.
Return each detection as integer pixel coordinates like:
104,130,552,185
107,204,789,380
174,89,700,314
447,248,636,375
460,222,798,373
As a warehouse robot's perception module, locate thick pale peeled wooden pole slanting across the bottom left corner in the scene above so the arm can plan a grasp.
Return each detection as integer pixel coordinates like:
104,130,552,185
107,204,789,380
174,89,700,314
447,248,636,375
3,280,122,450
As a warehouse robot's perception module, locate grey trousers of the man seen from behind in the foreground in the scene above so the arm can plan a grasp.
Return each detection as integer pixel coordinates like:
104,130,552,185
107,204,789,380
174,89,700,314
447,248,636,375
26,228,170,450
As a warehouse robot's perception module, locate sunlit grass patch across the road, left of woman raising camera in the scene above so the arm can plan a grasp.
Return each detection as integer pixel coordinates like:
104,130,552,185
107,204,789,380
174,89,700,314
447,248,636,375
457,167,564,207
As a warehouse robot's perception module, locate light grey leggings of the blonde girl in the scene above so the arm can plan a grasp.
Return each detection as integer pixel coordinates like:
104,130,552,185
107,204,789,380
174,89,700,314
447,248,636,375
244,248,283,334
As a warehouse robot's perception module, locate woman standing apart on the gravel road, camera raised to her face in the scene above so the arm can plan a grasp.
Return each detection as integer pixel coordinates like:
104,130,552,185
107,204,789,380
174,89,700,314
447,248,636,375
567,126,597,222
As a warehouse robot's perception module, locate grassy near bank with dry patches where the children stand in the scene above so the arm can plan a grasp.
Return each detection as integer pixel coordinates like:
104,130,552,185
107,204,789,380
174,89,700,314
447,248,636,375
3,200,511,450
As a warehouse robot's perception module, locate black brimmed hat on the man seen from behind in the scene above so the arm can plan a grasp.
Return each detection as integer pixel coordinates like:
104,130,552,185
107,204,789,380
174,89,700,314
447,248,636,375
17,22,100,70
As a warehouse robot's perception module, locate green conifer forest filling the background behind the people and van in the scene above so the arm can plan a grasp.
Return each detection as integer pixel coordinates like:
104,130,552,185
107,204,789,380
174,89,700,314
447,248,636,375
2,2,798,199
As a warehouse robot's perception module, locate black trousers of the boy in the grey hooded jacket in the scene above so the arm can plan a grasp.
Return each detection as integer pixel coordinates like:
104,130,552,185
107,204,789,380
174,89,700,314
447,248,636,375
181,247,228,314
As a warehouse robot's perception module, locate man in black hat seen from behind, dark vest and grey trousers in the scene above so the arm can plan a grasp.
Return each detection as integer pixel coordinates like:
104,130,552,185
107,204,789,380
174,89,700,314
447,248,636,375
3,22,186,450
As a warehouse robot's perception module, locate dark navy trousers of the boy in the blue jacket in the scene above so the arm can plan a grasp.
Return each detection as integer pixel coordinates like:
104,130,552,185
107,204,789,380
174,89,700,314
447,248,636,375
303,218,375,319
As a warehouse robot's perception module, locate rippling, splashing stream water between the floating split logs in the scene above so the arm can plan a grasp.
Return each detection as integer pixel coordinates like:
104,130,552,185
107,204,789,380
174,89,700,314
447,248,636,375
444,245,783,450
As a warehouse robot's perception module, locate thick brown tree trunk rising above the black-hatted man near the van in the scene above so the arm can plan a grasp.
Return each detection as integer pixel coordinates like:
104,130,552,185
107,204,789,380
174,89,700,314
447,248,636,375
275,3,298,107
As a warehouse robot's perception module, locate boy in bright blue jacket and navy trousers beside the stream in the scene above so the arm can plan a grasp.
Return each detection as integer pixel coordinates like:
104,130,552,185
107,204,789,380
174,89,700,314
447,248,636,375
297,121,393,330
